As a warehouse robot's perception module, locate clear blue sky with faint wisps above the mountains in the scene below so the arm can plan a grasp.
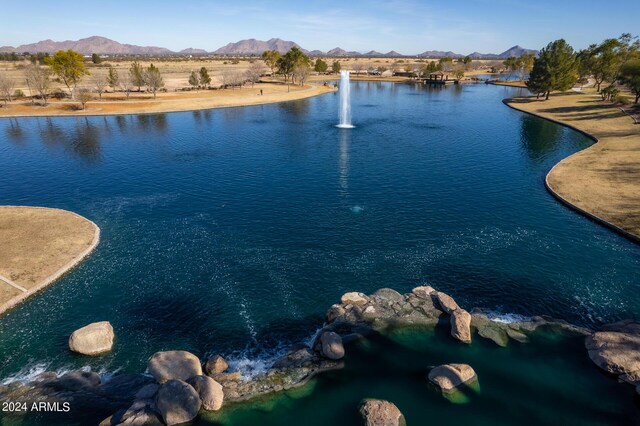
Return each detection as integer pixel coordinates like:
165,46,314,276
0,0,640,54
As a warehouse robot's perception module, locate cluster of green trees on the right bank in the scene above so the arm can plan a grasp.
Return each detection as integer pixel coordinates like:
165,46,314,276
526,34,640,104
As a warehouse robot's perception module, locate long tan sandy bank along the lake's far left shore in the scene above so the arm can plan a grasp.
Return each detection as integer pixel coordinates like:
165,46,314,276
0,83,336,119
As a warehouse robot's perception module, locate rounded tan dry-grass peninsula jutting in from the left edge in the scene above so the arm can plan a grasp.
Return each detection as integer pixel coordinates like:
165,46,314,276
0,206,100,314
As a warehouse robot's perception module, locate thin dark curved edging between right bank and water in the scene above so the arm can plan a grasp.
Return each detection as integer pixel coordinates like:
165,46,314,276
502,98,640,244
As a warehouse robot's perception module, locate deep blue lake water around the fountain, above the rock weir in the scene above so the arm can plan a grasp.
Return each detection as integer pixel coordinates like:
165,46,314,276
0,82,640,384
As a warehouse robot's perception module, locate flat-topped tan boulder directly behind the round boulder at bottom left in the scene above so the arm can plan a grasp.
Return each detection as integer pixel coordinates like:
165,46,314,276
147,351,202,383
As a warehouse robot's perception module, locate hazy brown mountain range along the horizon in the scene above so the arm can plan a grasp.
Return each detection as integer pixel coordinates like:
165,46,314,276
0,36,538,59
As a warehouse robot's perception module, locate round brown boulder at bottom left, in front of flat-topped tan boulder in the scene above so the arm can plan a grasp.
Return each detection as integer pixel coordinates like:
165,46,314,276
156,379,202,425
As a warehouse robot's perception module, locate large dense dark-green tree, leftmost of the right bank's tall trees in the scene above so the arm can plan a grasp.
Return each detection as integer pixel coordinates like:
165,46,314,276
526,39,578,99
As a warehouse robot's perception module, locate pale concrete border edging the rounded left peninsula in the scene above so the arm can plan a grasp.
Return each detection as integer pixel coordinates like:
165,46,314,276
0,206,100,315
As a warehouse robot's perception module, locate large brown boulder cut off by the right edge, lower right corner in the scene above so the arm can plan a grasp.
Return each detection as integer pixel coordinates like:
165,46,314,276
585,321,640,385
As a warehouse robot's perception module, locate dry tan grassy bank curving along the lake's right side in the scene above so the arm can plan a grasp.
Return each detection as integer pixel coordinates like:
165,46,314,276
504,92,640,242
